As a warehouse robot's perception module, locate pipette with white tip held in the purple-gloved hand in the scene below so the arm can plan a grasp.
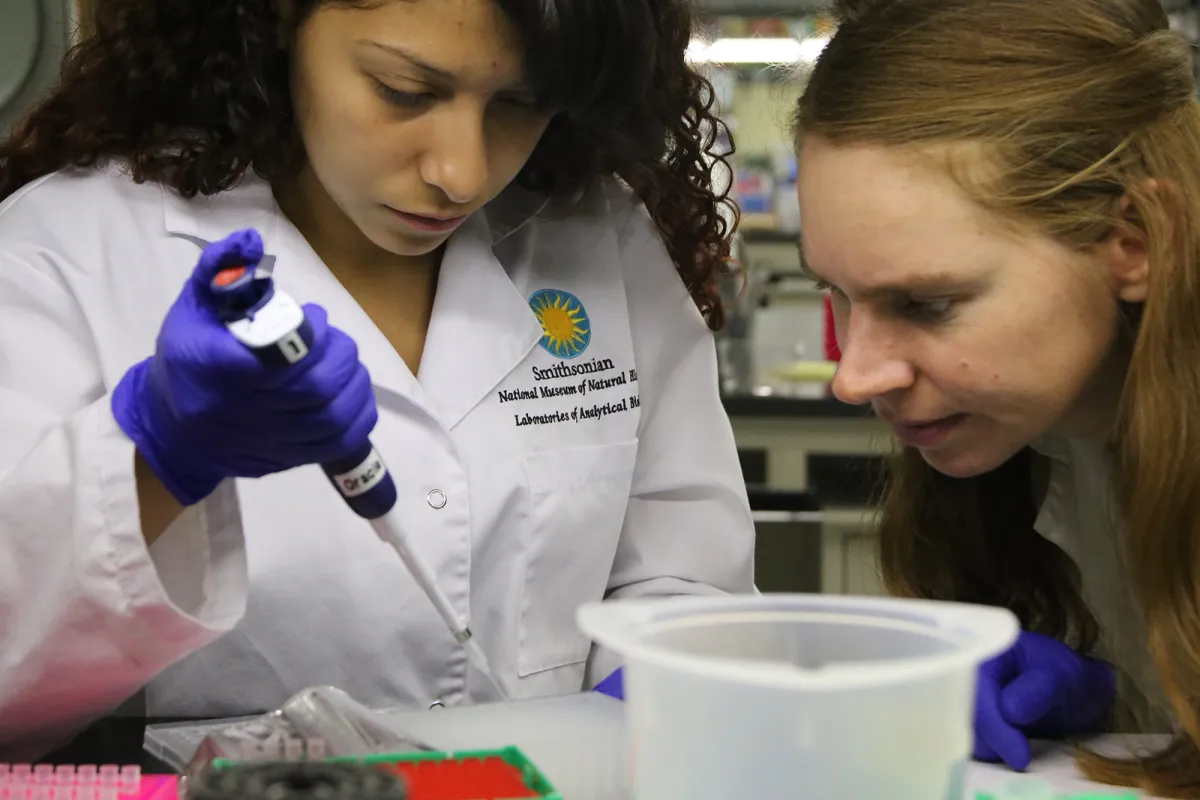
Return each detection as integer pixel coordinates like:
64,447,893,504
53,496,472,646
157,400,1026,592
210,260,508,699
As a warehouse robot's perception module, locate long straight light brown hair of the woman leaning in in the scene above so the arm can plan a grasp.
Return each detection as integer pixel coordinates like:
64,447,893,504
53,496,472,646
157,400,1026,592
796,0,1200,798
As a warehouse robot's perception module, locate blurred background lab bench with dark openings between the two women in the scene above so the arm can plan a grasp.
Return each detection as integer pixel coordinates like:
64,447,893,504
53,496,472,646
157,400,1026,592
724,395,893,595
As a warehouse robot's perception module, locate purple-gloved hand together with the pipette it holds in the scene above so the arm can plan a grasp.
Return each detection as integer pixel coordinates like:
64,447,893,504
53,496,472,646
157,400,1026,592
113,230,506,697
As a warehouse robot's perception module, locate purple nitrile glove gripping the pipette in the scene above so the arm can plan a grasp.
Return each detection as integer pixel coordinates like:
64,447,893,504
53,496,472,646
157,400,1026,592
112,230,377,505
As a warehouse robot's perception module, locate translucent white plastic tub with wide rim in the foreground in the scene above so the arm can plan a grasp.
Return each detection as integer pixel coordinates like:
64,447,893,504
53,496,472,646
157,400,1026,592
578,595,1019,800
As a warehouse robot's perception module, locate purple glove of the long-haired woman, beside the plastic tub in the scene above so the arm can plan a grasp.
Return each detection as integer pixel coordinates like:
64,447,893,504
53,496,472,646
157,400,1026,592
974,631,1116,770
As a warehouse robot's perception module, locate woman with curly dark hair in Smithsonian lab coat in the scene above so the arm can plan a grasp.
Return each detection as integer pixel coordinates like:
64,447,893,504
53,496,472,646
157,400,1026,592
0,0,752,760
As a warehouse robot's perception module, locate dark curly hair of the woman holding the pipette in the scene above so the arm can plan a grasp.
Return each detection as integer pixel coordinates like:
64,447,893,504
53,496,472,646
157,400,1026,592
0,0,738,330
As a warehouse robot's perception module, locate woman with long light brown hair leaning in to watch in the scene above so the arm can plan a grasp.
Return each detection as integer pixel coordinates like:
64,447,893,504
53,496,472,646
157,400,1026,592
796,0,1200,798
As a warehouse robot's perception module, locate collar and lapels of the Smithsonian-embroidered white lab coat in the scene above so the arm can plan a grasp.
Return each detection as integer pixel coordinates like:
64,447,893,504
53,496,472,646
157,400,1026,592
163,174,546,429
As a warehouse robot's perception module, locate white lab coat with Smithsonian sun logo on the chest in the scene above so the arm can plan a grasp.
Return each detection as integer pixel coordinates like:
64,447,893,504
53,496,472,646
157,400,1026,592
0,168,754,757
